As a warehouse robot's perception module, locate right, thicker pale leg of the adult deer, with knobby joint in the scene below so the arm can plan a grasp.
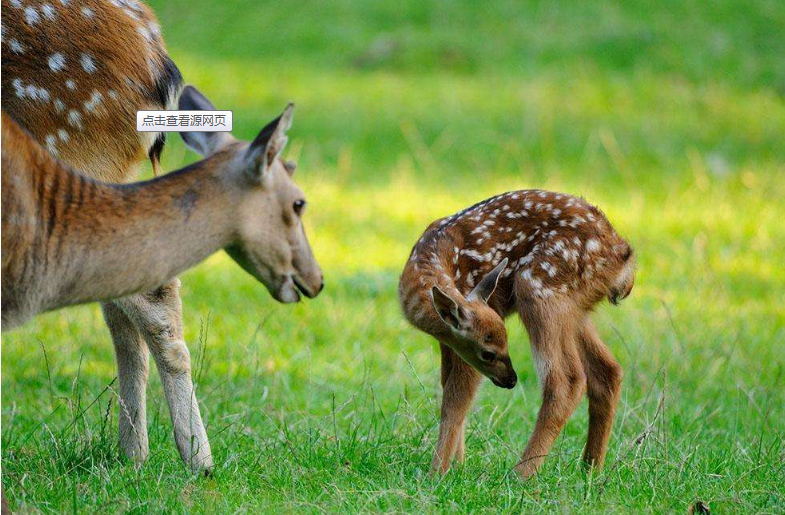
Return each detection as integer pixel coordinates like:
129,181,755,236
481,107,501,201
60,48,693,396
118,279,213,473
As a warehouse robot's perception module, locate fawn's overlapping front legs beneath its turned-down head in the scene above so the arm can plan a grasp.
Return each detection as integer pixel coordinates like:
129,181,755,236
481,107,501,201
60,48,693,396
431,343,481,474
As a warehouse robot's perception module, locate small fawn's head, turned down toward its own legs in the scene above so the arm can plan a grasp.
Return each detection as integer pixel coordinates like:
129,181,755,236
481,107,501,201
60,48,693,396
431,258,518,388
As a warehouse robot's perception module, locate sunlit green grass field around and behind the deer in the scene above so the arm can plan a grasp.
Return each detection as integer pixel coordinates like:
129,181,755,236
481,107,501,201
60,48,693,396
2,0,785,514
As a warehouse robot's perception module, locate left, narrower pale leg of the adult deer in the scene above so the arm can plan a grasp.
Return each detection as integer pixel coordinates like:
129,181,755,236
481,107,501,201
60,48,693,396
101,302,149,462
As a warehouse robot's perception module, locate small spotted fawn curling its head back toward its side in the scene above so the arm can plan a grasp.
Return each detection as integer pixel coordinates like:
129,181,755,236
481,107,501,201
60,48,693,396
398,190,635,478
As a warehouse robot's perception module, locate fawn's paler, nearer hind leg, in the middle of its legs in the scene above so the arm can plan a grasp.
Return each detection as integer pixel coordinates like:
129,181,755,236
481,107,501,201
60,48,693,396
515,296,586,479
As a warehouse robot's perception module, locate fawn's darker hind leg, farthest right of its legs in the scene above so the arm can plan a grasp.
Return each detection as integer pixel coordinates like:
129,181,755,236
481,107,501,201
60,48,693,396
578,317,623,470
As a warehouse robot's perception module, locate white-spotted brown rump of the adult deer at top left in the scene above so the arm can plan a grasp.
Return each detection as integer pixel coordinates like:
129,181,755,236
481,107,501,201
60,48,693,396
2,0,182,182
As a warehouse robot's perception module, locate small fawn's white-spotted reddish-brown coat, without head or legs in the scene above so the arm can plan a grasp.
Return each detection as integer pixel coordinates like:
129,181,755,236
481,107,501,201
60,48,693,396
399,190,634,330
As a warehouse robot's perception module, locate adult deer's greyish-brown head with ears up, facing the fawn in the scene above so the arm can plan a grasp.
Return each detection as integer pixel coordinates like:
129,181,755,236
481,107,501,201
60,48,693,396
179,86,324,303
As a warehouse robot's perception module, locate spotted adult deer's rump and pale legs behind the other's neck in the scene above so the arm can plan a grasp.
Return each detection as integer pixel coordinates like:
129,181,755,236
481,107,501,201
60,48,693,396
2,0,224,470
